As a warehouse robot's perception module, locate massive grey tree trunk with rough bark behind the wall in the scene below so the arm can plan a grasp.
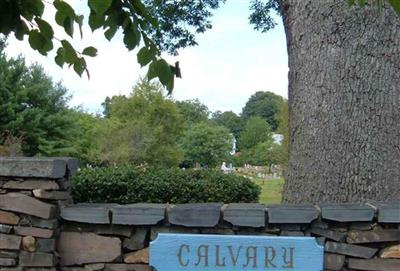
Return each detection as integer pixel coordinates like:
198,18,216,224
281,0,400,203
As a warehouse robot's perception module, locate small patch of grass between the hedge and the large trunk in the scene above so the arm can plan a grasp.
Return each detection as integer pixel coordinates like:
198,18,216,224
253,178,284,204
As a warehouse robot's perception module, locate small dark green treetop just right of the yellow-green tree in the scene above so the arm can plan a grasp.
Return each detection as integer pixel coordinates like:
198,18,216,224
175,99,210,127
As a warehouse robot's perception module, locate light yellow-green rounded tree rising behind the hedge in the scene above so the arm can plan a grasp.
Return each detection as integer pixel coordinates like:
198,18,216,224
91,80,183,166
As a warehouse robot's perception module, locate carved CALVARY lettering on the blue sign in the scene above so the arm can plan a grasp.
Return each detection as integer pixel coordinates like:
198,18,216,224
176,244,295,270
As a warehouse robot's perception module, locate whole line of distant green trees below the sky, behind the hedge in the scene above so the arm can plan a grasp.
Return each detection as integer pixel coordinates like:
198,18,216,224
0,39,287,170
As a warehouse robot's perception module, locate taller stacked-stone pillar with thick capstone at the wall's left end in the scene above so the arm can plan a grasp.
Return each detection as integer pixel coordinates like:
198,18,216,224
0,158,77,271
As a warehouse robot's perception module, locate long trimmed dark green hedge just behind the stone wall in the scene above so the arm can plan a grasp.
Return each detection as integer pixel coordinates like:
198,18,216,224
72,166,261,204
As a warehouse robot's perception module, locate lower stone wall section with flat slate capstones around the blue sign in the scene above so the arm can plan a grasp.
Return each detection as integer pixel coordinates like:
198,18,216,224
58,202,400,271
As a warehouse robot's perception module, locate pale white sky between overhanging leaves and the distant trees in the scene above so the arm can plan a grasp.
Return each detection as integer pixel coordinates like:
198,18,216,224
7,0,288,114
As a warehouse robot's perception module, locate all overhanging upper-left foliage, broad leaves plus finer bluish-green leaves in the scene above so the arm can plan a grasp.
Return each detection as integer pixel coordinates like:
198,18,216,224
0,0,230,91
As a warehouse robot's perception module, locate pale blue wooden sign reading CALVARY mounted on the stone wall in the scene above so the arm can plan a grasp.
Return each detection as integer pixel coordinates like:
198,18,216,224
150,233,324,271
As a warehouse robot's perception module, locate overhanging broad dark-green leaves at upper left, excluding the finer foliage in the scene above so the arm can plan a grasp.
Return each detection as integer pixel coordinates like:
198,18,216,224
0,0,164,91
